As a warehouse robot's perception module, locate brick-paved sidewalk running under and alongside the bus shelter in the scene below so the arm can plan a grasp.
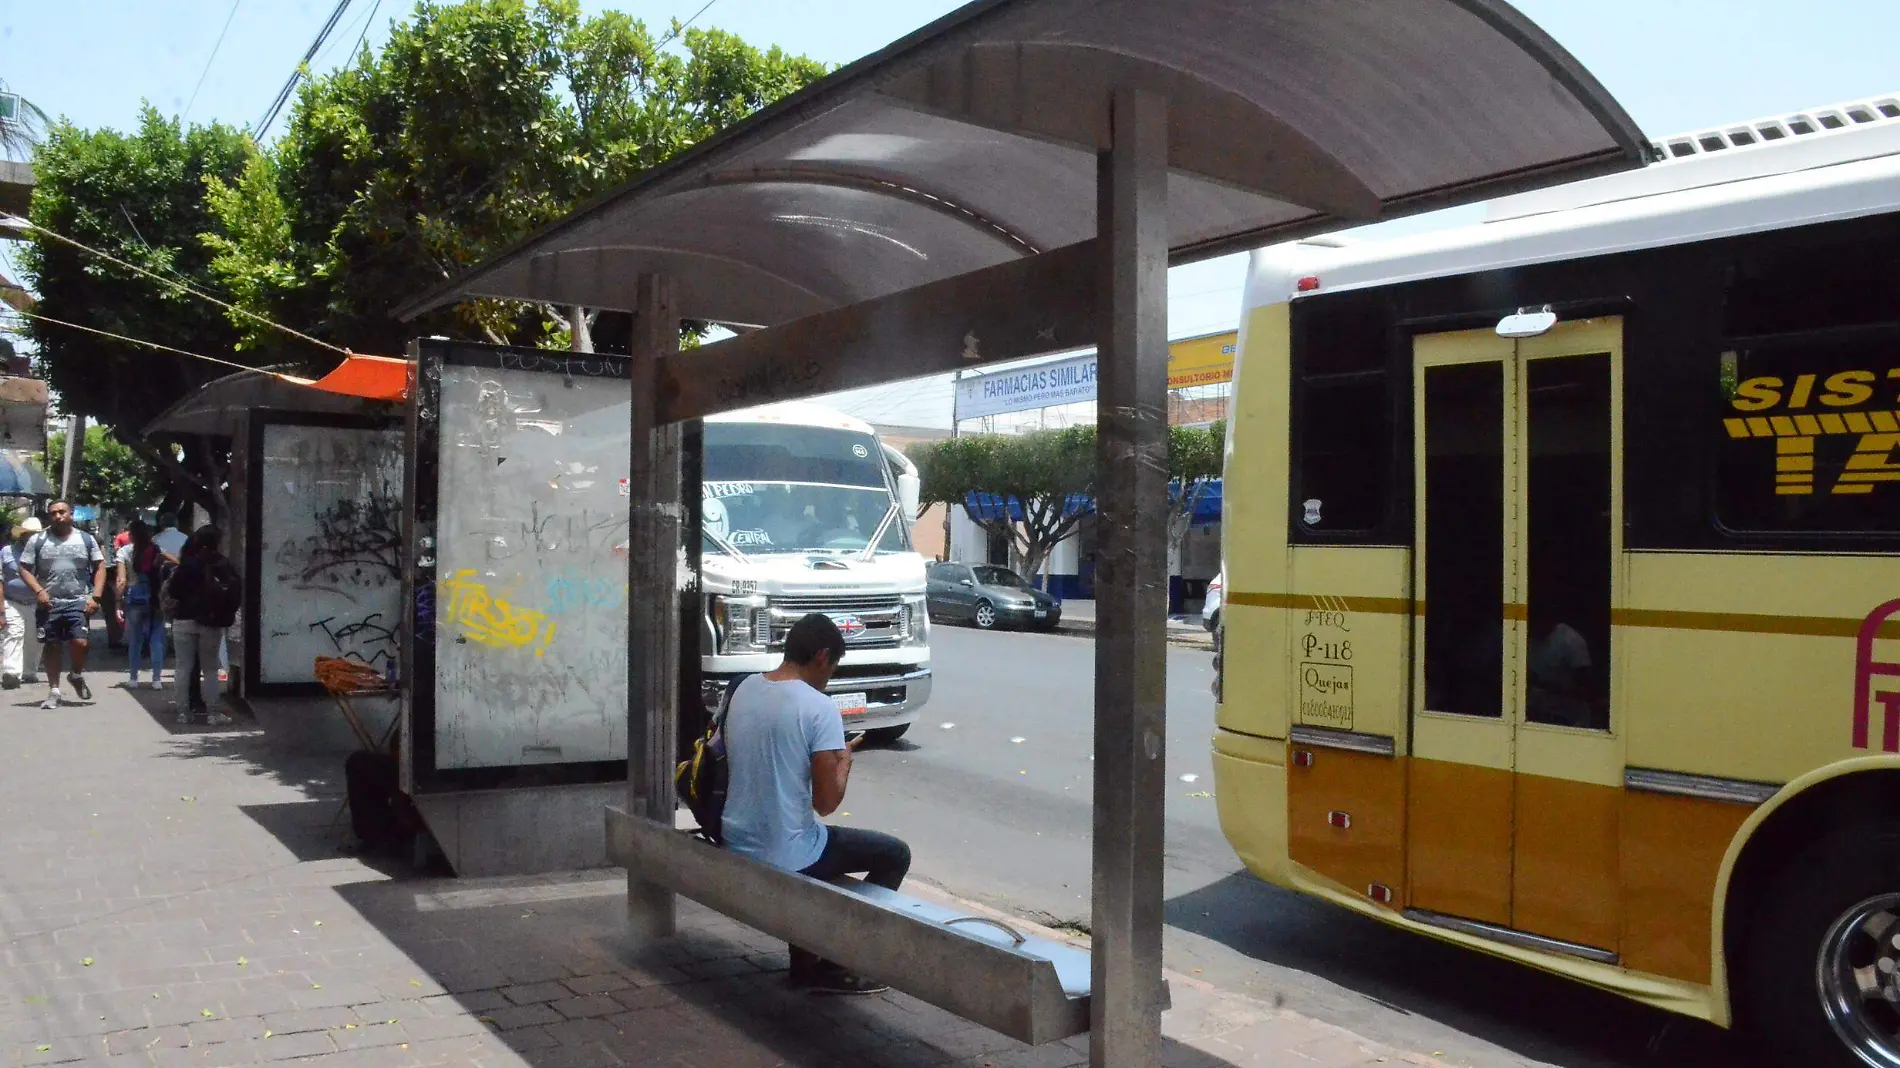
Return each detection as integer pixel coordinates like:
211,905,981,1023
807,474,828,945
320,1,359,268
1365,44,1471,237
0,673,1435,1068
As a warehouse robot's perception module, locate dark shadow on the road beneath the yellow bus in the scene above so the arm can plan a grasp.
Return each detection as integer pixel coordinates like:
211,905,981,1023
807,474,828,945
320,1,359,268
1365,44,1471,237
1167,874,1769,1068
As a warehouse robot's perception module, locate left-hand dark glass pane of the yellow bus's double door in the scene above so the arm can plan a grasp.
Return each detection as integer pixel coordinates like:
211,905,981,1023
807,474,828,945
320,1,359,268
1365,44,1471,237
1423,363,1505,716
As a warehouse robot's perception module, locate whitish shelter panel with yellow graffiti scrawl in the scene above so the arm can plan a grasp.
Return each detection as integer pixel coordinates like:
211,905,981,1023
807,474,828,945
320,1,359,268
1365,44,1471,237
435,362,633,768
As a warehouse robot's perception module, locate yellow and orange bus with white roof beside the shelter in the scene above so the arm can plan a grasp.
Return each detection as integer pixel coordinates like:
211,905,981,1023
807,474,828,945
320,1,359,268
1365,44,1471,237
1214,99,1900,1066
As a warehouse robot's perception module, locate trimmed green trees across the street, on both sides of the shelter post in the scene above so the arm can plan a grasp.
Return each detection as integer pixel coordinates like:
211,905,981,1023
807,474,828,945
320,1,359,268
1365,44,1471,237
912,422,1227,576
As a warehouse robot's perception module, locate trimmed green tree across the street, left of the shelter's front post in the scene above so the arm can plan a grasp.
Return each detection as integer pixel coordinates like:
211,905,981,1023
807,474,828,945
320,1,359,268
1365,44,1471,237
910,426,1096,576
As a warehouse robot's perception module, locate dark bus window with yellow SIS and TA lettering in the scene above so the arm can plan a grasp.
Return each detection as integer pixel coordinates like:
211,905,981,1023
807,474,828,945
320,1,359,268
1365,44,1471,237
1708,331,1900,534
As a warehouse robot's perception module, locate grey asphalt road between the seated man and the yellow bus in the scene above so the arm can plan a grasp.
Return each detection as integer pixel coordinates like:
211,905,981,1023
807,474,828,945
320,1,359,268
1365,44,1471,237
836,625,1758,1068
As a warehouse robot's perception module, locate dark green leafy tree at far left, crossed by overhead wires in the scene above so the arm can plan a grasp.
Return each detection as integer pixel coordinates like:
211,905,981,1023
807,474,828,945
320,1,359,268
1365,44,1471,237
19,105,251,519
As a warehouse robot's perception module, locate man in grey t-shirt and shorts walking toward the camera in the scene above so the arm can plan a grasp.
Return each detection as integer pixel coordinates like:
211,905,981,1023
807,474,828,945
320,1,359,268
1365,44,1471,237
19,500,106,709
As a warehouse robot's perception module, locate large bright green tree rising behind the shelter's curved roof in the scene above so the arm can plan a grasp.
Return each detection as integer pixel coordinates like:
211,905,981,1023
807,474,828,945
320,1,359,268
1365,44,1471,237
207,0,825,355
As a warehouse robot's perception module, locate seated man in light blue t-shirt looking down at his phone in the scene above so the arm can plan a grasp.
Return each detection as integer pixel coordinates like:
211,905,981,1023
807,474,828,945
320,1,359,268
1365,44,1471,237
722,612,910,994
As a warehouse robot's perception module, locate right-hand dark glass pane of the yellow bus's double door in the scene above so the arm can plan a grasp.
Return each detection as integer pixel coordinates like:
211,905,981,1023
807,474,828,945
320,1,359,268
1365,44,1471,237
1524,355,1613,730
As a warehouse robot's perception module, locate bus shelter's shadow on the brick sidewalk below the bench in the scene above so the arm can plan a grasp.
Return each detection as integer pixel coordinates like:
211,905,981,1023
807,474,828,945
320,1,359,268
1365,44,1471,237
323,870,1229,1068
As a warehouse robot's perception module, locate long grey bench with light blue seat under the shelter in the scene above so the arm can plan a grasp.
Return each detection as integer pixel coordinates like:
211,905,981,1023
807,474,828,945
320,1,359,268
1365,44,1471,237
606,808,1091,1045
